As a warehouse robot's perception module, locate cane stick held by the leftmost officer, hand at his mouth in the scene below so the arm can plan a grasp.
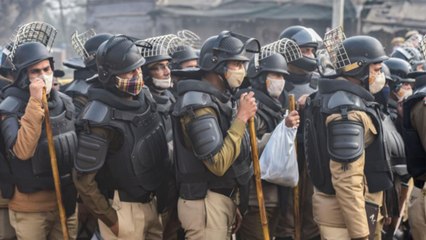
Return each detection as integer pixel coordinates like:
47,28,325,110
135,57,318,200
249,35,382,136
42,88,69,240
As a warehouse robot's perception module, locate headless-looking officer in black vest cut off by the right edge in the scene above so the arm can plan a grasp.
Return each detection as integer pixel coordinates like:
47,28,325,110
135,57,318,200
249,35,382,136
403,68,426,239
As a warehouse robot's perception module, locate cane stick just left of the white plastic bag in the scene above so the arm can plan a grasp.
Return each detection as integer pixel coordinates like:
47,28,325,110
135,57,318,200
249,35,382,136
249,117,270,240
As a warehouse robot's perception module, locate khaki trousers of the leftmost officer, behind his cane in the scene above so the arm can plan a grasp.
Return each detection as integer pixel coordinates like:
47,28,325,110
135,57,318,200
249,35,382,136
9,209,78,240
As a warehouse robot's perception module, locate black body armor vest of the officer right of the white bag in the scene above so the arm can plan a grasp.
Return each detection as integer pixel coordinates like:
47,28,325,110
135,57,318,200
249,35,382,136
304,79,392,194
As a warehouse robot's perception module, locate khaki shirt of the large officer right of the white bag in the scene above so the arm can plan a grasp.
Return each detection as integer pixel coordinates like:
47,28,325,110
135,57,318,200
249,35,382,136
312,111,383,238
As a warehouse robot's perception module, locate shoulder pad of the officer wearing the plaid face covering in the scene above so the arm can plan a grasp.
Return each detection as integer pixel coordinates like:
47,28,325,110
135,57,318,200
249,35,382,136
81,100,111,124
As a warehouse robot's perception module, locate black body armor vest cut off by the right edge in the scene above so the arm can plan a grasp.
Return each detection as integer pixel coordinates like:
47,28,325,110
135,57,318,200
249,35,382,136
402,86,426,182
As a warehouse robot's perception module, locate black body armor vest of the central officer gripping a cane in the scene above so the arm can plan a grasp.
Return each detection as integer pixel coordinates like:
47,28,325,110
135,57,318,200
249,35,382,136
172,80,253,200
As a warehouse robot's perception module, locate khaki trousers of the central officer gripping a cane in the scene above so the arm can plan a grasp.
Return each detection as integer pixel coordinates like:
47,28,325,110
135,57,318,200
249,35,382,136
178,190,236,240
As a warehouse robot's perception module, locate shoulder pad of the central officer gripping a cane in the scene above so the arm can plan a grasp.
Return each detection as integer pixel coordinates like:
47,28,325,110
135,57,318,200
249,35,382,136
174,91,214,116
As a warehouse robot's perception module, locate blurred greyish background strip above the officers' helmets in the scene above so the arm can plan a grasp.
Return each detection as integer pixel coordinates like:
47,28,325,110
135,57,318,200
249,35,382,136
0,0,426,78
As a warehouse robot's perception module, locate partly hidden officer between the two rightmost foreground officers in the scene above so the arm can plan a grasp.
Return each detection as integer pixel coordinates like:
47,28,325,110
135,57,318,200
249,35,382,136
374,58,414,239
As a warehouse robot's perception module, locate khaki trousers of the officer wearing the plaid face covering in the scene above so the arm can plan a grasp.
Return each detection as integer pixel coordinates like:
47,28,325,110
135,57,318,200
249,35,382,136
98,191,163,240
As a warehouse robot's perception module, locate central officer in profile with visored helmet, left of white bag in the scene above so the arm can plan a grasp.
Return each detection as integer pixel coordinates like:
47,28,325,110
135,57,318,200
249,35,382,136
173,31,259,239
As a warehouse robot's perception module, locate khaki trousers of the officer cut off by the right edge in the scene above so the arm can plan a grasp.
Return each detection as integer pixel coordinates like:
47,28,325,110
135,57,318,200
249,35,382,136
408,185,426,240
